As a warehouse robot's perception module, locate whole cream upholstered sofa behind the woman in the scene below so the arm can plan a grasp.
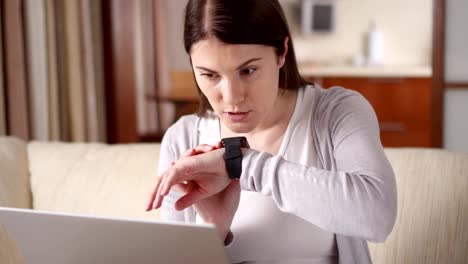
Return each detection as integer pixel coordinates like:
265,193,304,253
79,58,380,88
0,137,468,264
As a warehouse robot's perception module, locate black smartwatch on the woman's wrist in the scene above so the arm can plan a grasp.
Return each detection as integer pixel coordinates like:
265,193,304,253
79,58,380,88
221,137,250,179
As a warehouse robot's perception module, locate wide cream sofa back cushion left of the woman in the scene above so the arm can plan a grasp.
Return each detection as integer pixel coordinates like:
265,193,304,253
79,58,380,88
28,142,159,219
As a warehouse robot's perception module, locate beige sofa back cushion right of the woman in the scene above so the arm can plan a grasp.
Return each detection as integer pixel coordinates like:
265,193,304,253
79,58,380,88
369,149,468,264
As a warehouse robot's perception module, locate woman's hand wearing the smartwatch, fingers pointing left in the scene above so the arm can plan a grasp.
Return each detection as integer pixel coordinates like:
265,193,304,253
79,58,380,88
150,145,231,210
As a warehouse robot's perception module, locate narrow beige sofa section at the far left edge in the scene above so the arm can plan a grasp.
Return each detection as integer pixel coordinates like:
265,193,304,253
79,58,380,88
0,137,31,208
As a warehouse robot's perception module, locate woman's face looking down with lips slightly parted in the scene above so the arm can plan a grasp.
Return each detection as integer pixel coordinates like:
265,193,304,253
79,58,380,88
190,38,284,133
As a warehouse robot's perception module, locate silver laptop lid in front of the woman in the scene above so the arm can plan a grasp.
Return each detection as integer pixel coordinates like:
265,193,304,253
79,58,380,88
0,207,228,264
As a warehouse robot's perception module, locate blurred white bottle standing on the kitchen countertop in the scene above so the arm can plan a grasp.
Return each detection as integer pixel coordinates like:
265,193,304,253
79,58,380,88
367,20,384,66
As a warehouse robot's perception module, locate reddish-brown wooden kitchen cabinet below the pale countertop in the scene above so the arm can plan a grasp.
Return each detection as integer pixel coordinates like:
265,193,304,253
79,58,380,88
309,77,432,147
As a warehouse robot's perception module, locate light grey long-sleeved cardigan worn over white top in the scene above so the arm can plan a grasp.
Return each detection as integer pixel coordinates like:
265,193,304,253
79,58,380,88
159,86,397,264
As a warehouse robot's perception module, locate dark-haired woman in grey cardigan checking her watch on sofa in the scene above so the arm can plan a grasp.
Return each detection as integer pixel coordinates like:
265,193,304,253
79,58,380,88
147,0,396,263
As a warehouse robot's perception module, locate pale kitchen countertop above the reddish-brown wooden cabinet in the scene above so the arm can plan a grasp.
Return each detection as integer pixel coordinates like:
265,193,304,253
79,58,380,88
299,64,432,78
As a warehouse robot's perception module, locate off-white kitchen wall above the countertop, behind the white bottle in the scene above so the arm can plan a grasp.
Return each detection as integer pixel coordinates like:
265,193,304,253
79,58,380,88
280,0,432,65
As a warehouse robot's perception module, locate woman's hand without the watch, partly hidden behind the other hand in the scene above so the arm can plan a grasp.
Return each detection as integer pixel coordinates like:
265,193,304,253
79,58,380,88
148,142,240,239
